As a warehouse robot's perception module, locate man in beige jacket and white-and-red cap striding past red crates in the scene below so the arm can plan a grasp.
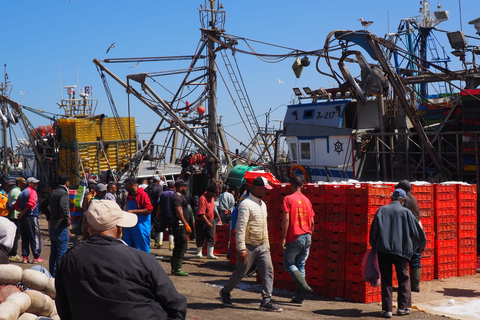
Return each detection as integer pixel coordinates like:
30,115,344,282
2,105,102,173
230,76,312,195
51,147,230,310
220,177,282,312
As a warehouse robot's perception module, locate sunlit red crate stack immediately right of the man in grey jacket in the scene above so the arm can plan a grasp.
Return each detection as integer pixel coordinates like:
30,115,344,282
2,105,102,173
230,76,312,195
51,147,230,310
412,183,435,281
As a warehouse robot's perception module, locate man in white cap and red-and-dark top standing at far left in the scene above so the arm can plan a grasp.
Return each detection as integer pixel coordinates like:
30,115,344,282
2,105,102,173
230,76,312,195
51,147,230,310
13,177,45,263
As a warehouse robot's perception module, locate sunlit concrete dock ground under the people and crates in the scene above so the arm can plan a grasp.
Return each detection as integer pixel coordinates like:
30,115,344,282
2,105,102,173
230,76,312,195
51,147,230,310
14,218,480,320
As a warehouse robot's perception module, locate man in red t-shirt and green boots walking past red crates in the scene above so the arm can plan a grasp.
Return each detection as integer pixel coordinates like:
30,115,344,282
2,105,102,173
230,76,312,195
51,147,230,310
281,175,315,303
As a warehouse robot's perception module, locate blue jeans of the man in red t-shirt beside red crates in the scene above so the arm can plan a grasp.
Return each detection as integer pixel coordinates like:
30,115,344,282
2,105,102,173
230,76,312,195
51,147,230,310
283,233,312,278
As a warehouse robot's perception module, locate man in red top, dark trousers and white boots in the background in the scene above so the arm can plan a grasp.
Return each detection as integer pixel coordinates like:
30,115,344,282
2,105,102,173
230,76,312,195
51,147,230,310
195,184,222,259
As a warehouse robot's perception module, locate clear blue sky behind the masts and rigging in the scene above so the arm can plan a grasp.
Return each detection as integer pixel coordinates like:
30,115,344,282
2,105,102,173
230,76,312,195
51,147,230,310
0,0,480,155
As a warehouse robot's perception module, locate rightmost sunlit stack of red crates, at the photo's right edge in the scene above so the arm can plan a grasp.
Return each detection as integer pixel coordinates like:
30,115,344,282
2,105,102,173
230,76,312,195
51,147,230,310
457,184,477,277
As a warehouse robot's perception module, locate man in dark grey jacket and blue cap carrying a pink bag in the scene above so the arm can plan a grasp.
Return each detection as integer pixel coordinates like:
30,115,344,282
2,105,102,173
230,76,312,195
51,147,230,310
370,189,426,318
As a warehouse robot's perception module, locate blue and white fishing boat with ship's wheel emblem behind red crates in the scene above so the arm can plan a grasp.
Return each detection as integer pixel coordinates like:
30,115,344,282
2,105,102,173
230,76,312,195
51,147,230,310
283,1,480,188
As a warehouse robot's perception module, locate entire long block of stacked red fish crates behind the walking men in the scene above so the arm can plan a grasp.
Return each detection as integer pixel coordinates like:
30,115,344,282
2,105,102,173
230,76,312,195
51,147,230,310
240,183,477,303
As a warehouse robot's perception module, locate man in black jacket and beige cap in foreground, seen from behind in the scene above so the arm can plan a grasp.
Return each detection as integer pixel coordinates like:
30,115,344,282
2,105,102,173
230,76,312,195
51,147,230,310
55,200,187,320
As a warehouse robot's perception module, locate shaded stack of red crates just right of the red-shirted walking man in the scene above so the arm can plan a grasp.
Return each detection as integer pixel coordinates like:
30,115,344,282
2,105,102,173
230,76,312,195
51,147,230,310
323,184,348,298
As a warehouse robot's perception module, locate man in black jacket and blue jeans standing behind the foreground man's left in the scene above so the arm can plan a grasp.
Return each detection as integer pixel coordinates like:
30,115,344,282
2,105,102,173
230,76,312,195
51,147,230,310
45,174,71,277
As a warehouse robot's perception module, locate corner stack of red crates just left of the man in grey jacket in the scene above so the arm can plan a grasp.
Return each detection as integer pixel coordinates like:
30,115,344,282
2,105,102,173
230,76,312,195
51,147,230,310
345,183,392,303
